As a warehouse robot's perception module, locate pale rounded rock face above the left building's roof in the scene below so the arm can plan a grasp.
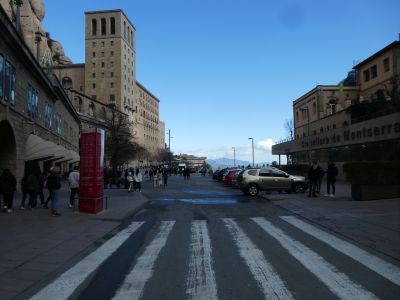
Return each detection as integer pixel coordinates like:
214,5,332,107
0,0,72,65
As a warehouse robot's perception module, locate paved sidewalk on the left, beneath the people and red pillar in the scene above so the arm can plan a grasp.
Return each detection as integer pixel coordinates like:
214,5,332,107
0,183,148,299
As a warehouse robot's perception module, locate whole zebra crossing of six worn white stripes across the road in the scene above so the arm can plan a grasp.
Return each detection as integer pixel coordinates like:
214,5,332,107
31,216,400,300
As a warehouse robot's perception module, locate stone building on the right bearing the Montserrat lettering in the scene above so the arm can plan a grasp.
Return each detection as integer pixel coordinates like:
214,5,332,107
272,41,400,172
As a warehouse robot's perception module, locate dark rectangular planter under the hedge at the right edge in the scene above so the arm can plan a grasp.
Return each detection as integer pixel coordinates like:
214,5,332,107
351,184,400,201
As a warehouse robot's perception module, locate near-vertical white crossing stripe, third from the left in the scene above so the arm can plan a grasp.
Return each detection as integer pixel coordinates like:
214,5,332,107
186,220,218,300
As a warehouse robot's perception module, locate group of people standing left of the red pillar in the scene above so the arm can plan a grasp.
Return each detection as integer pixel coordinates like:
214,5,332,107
0,167,79,216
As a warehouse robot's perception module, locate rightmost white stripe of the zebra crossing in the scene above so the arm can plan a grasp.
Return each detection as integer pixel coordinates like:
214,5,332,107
281,216,400,285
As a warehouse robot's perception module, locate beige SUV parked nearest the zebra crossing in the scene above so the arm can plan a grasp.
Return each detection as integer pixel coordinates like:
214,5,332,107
238,167,308,196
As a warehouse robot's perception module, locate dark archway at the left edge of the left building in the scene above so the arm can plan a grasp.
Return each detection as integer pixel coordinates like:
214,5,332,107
0,120,17,175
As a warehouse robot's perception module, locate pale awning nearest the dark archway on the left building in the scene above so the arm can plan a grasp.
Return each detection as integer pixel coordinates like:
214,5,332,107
24,134,57,161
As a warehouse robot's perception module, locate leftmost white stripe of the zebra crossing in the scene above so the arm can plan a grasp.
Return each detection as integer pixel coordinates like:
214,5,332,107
30,222,144,300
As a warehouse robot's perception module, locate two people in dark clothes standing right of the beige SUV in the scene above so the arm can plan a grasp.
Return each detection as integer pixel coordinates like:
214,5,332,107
308,160,339,197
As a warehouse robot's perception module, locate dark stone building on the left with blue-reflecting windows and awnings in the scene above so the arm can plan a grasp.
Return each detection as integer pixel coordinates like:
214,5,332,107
0,7,79,183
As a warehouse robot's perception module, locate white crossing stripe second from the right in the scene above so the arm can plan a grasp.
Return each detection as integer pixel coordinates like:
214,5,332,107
251,218,377,300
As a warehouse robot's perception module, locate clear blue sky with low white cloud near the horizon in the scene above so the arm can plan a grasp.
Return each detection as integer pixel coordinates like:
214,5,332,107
42,0,400,162
